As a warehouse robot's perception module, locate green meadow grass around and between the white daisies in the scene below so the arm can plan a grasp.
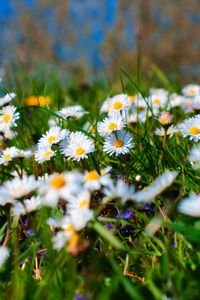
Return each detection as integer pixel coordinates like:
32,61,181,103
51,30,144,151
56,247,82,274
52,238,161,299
0,66,200,300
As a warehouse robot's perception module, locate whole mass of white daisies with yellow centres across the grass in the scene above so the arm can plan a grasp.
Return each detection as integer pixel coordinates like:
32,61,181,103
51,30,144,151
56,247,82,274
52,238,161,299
0,84,200,267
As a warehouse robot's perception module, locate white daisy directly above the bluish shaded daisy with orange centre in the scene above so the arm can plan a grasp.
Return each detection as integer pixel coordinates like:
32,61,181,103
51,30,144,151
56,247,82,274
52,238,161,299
97,114,126,136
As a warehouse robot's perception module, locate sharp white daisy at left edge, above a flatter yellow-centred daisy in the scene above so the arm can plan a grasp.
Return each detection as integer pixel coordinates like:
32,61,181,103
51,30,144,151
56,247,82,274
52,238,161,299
0,105,20,131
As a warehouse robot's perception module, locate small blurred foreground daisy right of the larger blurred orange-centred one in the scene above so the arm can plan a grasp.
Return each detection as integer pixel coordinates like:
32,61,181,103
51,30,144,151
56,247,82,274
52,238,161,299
84,170,112,191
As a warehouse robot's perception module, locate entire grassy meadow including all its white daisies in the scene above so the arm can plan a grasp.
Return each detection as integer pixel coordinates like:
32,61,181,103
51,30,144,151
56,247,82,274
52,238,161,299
0,66,200,300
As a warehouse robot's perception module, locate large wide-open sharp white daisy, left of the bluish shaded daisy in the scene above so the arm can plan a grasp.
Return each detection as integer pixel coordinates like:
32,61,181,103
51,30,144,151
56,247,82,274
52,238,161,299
61,131,95,161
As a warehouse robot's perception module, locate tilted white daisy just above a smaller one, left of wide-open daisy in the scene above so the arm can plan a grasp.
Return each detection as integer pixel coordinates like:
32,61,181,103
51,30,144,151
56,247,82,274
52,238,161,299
38,126,69,149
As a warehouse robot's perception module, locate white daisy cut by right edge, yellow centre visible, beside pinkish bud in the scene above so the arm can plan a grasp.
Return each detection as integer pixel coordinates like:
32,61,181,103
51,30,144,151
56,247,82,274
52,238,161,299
179,115,200,142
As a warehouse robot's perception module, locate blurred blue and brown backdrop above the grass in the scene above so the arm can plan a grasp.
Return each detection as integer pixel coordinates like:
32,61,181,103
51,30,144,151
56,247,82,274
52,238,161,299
0,0,200,82
